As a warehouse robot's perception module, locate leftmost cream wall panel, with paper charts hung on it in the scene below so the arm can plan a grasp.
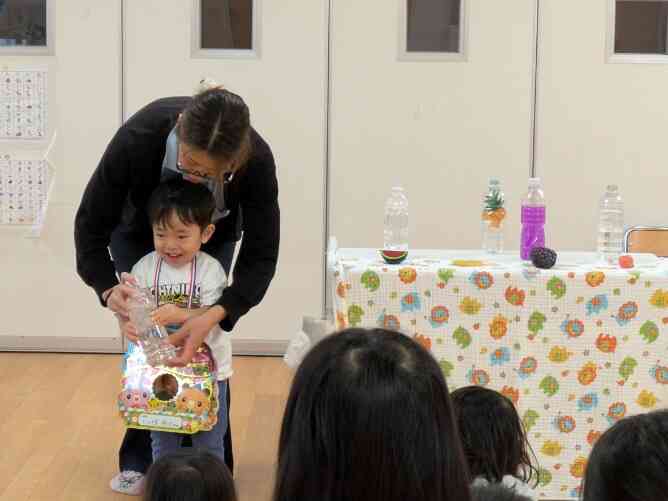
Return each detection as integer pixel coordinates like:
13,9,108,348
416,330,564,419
0,0,120,349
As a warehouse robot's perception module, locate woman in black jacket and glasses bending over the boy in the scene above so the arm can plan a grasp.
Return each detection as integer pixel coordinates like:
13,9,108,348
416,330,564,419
74,87,280,494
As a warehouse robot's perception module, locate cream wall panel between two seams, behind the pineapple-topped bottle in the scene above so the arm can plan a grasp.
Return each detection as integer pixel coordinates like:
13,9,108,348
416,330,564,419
331,0,535,248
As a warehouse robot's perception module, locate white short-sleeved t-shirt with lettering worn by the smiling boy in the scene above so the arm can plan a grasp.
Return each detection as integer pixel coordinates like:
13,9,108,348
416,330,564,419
131,251,232,381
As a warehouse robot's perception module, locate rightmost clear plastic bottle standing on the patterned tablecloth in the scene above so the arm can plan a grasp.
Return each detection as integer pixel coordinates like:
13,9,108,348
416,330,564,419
596,184,624,264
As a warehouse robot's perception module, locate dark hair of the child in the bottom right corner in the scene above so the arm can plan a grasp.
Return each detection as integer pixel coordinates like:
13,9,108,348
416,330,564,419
582,410,668,501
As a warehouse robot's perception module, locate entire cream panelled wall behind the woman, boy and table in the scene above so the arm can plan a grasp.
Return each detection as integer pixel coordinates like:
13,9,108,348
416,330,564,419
0,0,668,349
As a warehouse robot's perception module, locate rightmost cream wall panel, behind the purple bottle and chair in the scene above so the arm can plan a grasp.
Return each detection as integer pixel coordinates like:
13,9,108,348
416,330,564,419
536,0,668,250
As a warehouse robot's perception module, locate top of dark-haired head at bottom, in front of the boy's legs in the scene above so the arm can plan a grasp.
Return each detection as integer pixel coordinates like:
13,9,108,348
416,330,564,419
144,448,237,501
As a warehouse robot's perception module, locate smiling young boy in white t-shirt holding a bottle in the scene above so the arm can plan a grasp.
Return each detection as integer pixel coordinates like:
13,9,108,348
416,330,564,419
119,179,232,468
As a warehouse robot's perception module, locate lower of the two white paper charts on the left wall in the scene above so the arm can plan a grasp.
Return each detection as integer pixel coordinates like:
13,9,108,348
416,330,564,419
0,153,50,229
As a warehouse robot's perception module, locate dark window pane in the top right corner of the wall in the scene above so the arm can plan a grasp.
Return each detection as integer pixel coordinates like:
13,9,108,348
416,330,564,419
614,0,668,55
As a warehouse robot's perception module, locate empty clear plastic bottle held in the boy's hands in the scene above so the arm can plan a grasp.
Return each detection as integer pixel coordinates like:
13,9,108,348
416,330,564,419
128,287,176,367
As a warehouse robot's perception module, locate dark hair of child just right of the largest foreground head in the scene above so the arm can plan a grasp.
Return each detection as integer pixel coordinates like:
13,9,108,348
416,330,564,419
451,386,538,484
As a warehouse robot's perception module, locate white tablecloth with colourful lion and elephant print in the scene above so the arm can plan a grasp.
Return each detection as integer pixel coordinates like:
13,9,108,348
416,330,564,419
332,249,668,499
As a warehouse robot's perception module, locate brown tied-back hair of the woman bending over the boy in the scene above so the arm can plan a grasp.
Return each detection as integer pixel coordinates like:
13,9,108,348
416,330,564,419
176,87,251,175
